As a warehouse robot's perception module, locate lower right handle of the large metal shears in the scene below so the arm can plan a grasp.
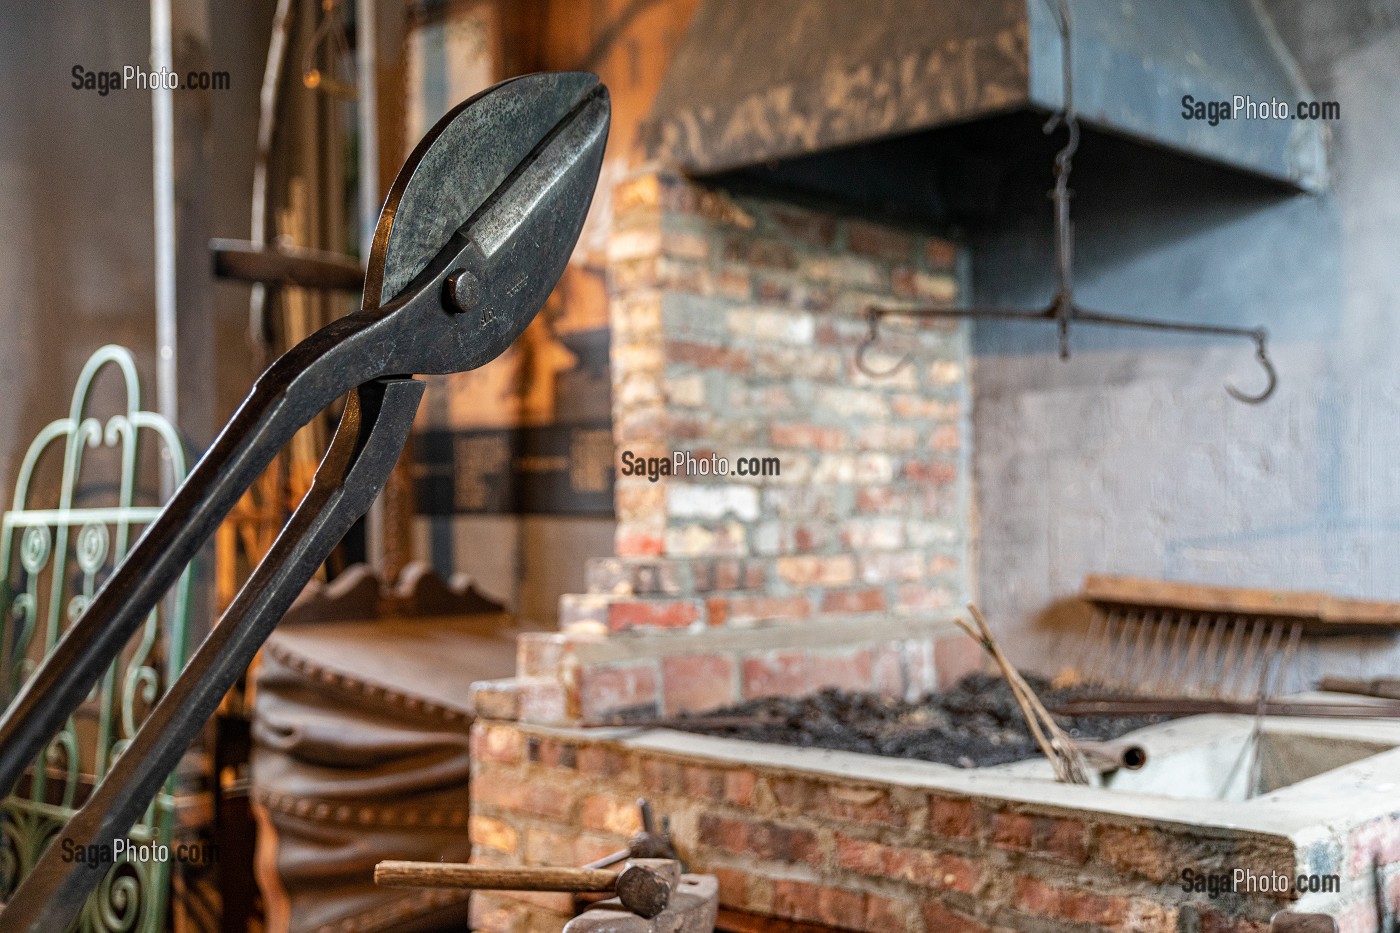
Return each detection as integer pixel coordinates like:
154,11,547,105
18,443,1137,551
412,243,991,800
0,378,424,933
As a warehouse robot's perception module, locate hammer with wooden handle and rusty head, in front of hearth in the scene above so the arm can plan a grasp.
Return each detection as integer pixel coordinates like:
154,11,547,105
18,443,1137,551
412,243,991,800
374,859,680,919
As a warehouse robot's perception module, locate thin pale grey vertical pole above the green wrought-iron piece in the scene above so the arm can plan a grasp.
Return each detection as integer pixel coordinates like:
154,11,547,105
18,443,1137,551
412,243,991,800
151,0,179,427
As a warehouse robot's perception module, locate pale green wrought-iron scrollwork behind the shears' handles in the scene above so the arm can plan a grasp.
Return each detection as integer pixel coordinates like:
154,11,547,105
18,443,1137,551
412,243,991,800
0,345,189,933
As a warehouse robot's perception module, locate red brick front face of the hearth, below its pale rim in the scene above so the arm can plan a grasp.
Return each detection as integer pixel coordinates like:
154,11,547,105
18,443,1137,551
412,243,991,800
470,721,1355,933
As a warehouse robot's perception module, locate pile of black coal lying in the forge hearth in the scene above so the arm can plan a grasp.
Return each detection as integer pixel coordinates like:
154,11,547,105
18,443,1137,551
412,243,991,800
655,674,1170,768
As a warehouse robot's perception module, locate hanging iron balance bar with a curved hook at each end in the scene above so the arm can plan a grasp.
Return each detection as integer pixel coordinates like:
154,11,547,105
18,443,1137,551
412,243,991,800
855,0,1278,405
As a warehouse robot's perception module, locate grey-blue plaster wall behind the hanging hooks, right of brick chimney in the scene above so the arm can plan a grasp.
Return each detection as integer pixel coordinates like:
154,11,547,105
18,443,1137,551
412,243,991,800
972,0,1400,679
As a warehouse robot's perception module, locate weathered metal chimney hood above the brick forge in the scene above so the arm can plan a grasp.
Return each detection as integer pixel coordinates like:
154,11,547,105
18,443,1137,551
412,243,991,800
644,0,1326,191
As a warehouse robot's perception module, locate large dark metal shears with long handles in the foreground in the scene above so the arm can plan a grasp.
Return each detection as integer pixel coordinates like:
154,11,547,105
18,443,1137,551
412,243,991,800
0,74,609,933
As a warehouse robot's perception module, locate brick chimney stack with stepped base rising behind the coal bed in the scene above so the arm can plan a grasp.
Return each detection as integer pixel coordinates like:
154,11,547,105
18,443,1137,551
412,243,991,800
477,171,980,721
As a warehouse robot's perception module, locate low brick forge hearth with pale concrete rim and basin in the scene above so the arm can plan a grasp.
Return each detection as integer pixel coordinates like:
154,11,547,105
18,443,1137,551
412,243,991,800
470,706,1400,933
